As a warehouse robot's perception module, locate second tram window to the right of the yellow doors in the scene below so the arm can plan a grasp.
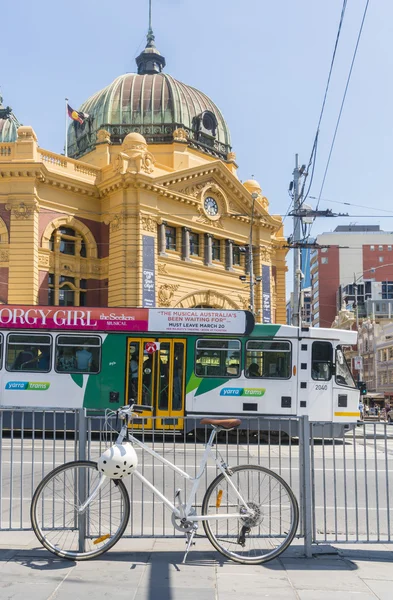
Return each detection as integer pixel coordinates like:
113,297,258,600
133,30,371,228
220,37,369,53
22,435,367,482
245,340,292,379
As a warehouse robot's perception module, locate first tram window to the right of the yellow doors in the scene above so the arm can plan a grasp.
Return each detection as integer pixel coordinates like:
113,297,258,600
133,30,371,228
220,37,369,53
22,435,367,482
195,339,241,377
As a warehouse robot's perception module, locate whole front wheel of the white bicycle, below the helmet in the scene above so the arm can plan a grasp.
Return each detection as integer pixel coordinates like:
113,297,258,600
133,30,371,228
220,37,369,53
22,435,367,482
30,460,130,560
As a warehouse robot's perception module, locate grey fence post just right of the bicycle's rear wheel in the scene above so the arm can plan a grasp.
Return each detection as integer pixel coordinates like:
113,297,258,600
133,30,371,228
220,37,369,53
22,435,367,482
299,415,313,558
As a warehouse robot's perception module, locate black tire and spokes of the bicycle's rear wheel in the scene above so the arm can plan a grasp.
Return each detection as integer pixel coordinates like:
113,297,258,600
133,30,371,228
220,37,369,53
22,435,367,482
202,465,299,564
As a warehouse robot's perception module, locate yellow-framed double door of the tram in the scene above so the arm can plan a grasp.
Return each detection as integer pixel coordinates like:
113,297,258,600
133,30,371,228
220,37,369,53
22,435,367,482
126,338,186,430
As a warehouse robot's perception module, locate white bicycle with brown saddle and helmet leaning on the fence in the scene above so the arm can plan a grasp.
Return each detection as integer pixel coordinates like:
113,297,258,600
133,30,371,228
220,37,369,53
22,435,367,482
31,404,299,564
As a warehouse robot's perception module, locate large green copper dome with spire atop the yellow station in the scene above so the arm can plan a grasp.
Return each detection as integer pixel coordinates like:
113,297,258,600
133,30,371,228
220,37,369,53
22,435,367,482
68,34,231,160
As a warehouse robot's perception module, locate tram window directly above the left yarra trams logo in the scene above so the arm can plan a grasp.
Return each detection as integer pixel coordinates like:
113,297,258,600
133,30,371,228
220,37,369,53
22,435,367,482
6,333,52,373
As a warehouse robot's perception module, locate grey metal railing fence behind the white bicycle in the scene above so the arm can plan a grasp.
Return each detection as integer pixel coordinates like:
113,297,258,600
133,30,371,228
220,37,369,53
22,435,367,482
0,409,393,555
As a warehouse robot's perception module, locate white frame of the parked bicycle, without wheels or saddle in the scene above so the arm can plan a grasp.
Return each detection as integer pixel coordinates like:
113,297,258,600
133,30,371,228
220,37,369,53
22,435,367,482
78,424,253,521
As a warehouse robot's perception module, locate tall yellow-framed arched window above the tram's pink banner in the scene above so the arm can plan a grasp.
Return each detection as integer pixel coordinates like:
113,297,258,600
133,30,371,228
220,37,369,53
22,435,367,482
48,226,87,306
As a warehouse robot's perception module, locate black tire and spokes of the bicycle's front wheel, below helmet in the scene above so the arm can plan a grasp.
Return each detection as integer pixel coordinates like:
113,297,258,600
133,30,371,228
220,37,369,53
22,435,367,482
30,460,130,561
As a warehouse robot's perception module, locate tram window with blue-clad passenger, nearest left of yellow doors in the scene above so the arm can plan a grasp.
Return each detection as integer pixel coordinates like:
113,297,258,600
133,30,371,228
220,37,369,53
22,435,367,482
56,335,101,373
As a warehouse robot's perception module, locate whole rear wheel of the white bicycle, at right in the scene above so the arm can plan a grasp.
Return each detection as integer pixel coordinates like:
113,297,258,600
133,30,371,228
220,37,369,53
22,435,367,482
202,465,299,564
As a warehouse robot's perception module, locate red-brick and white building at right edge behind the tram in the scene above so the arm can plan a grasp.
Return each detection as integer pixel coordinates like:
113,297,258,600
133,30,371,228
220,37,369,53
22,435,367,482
311,225,393,327
